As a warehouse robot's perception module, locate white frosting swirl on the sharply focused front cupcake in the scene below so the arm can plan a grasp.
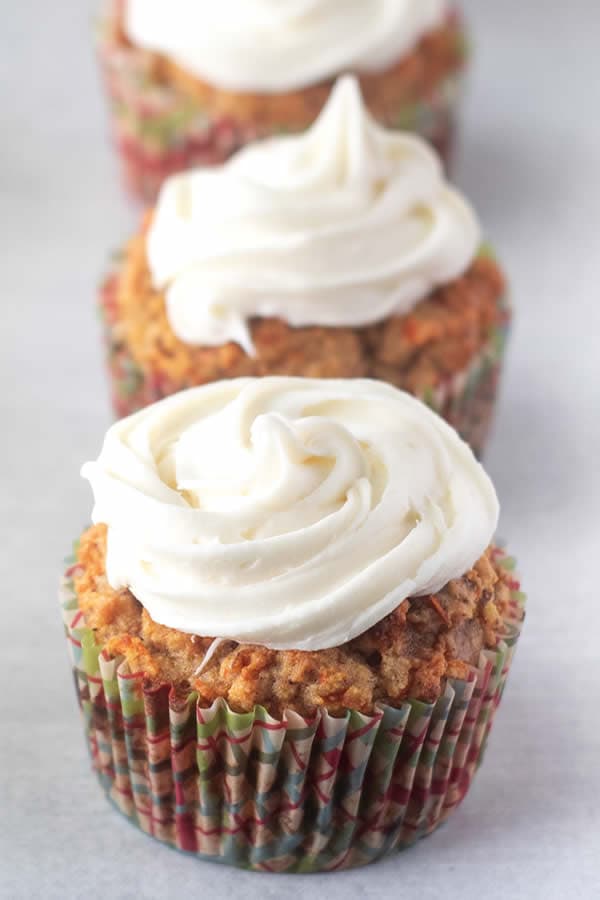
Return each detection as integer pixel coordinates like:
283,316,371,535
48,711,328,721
82,377,498,650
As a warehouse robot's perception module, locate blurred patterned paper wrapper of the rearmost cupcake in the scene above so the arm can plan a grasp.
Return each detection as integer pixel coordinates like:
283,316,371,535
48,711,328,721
98,5,463,202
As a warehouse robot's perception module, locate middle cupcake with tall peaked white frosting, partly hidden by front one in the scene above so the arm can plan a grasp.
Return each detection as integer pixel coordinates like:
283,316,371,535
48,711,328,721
101,78,508,452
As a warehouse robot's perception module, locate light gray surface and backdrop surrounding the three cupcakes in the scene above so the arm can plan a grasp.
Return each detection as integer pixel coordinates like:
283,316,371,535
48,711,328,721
0,0,600,900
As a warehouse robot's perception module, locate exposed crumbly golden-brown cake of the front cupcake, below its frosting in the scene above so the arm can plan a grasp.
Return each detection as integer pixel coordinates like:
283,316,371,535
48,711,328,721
73,525,510,717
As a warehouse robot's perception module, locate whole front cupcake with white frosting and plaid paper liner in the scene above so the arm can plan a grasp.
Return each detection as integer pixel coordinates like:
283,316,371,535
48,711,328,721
63,378,523,871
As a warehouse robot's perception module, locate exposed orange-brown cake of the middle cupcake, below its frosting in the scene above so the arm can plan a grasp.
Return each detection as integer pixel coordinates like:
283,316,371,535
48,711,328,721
110,221,507,396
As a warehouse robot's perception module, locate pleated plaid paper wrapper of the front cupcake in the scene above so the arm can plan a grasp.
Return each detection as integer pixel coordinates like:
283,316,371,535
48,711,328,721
61,552,524,872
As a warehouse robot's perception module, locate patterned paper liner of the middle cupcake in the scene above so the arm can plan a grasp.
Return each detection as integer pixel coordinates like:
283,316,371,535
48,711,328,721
99,250,511,456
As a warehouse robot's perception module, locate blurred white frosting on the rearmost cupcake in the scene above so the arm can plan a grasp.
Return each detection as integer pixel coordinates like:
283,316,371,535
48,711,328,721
125,0,448,93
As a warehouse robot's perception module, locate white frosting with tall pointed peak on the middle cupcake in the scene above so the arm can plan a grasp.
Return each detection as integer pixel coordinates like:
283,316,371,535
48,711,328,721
147,76,480,354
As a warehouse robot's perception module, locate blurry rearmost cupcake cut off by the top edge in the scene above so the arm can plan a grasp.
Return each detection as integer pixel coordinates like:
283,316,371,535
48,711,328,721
100,0,466,200
